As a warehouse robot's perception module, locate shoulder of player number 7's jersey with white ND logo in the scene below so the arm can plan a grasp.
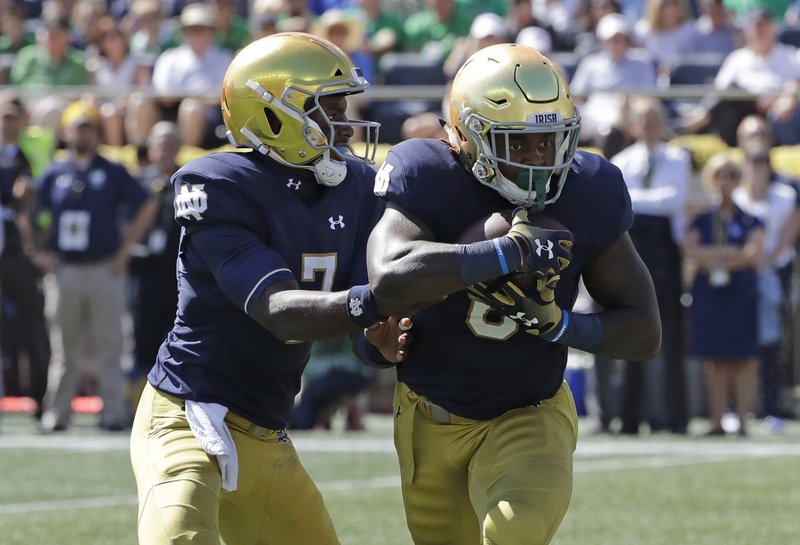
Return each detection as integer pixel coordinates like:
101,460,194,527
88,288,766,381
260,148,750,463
172,153,252,226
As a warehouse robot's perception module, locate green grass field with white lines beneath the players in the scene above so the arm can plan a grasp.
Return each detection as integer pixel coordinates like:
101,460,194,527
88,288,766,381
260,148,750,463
0,414,800,545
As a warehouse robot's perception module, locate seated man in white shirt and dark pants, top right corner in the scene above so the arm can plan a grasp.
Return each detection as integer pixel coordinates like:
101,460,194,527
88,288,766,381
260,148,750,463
682,8,800,146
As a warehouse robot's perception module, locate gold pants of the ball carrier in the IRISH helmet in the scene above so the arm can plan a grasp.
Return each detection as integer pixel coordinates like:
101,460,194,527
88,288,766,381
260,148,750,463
394,382,578,545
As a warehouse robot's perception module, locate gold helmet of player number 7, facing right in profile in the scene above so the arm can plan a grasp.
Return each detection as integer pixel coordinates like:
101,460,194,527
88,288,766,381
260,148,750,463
221,32,380,186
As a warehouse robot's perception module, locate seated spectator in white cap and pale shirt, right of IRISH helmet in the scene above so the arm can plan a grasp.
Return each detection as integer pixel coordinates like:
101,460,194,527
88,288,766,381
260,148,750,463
570,13,656,151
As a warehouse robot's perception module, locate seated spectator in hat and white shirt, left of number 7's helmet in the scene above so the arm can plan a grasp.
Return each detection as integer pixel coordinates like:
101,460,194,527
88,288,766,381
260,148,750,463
125,3,233,147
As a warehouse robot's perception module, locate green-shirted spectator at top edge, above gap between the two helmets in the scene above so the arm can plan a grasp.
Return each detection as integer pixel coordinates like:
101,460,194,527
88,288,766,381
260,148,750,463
403,0,474,62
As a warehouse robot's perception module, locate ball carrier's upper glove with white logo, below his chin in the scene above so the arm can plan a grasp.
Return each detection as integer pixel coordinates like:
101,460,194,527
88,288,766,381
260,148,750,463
505,208,574,280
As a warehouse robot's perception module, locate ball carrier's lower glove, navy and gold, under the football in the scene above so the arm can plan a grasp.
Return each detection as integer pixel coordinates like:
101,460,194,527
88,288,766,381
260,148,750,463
467,275,563,340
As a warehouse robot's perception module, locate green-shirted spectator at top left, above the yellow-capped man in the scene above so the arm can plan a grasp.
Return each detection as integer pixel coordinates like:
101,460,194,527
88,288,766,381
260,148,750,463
10,17,88,87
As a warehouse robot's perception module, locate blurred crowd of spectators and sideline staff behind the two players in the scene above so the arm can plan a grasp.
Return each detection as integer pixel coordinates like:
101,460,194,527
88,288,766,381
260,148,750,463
0,0,800,435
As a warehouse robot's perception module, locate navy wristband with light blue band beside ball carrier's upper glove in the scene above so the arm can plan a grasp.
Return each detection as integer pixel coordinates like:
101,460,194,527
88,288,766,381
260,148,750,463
457,236,522,286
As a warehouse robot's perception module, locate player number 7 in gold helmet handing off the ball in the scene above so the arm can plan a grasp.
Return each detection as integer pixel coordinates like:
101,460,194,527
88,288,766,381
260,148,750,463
131,33,406,545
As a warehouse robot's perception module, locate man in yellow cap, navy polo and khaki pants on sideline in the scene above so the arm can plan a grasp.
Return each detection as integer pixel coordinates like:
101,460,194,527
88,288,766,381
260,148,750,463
35,101,156,433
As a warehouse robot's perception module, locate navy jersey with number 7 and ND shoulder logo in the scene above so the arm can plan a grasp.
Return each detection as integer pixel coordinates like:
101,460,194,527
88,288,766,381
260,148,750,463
148,152,384,428
